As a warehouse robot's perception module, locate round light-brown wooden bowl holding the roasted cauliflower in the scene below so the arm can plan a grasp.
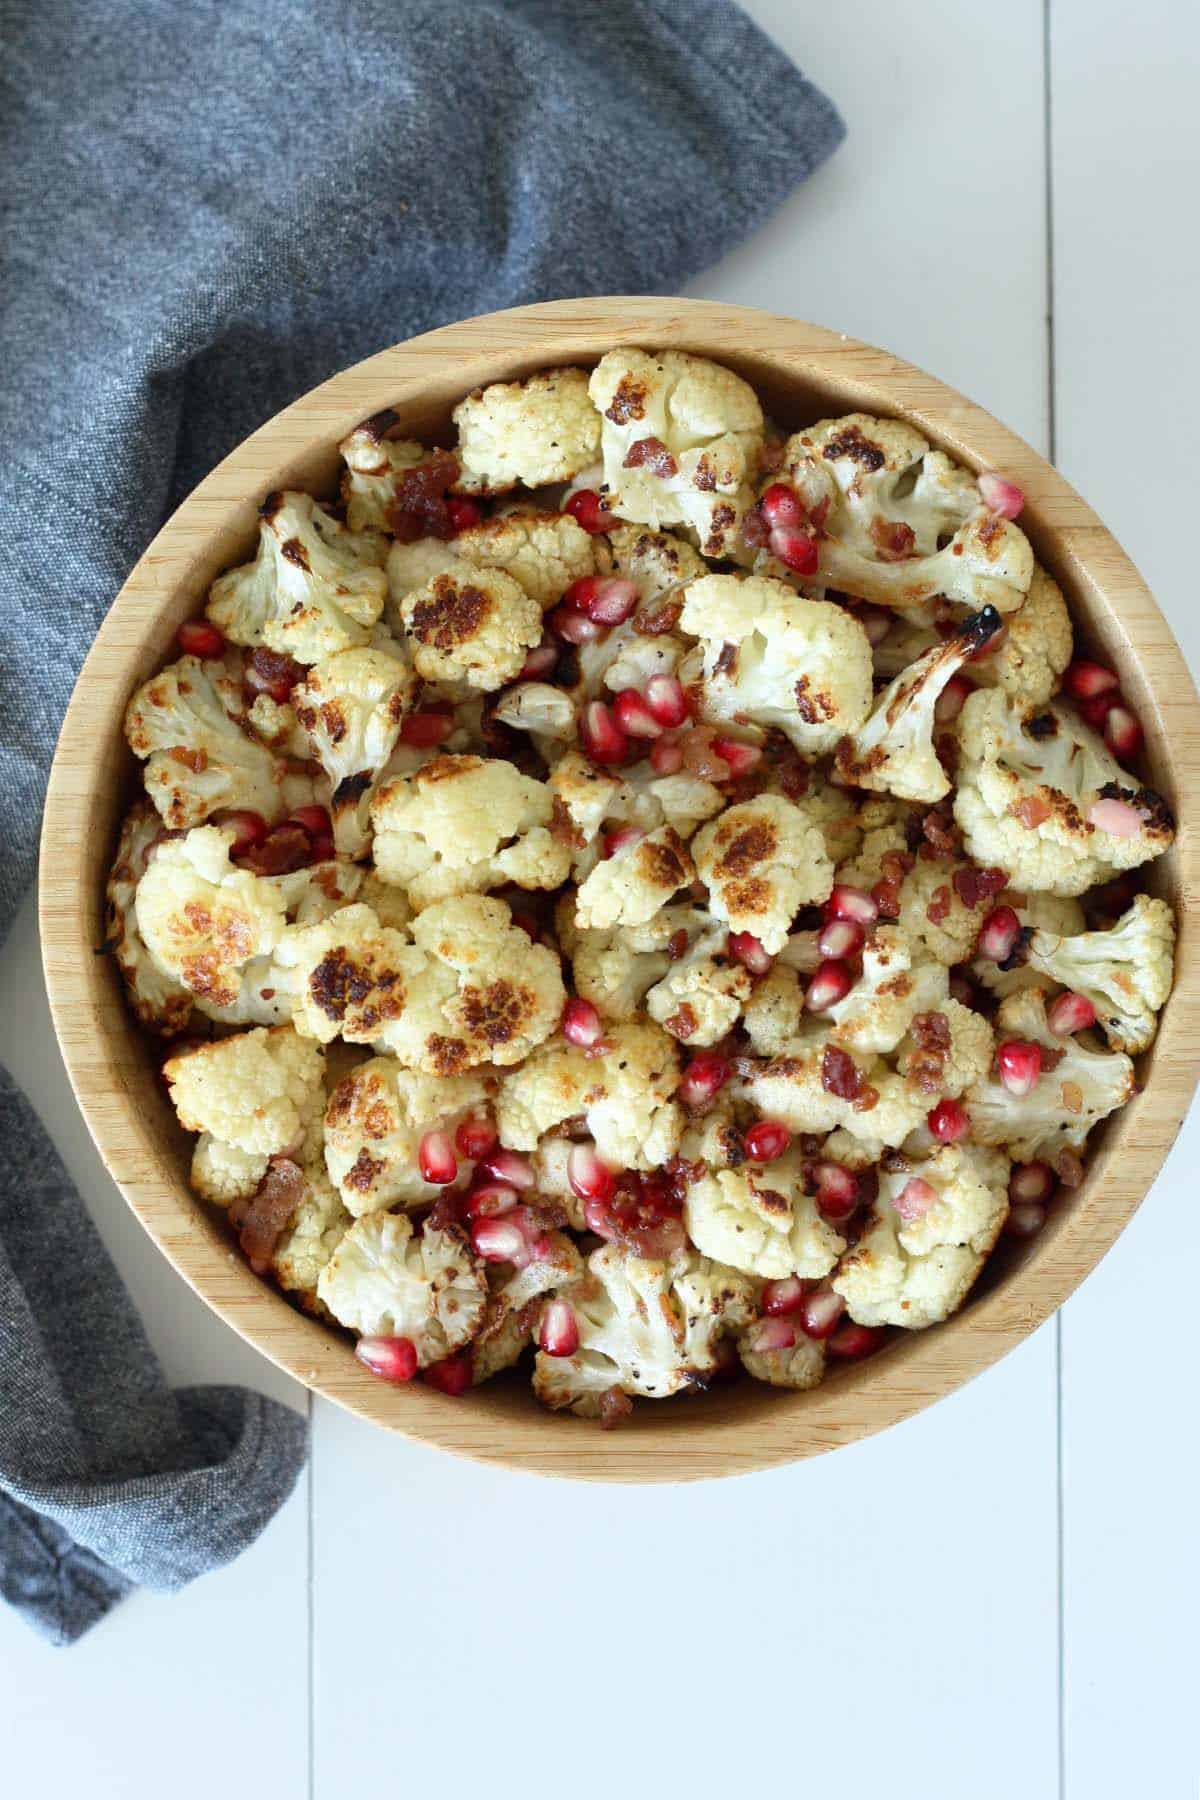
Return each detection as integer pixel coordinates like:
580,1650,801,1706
40,299,1200,1481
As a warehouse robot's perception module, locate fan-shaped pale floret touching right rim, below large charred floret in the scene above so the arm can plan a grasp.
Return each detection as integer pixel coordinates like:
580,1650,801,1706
1027,895,1175,1055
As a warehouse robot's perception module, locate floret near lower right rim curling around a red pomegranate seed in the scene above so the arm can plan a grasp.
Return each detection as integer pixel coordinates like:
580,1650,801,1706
966,988,1137,1163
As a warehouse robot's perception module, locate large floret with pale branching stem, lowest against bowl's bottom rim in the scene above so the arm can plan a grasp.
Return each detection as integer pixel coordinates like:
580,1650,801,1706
533,1244,754,1418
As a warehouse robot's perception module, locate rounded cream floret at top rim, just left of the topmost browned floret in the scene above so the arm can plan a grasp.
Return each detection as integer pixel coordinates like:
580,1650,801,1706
453,369,601,493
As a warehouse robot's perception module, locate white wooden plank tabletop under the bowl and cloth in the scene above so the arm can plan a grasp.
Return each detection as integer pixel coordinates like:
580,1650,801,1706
0,0,1200,1800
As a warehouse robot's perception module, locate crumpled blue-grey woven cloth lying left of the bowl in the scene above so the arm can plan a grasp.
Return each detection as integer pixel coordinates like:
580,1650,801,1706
0,0,842,1642
